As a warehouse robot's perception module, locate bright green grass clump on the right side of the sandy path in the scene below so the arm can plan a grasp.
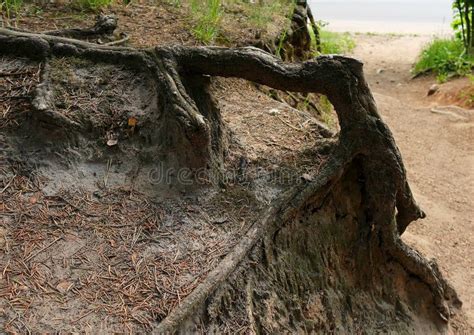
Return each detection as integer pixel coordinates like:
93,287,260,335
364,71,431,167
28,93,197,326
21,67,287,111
413,39,474,81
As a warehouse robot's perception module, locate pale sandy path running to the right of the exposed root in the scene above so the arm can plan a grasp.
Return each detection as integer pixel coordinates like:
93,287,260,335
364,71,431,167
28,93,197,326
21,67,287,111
354,35,474,325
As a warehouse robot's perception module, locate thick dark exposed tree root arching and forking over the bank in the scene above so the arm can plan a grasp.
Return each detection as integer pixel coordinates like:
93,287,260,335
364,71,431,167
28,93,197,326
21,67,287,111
0,29,459,332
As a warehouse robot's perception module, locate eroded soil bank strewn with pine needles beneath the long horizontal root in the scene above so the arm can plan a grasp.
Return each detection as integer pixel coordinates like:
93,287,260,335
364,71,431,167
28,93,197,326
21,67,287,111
1,1,468,333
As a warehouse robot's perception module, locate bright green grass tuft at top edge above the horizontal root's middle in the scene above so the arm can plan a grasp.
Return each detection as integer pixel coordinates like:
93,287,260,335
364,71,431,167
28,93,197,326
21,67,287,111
191,0,222,44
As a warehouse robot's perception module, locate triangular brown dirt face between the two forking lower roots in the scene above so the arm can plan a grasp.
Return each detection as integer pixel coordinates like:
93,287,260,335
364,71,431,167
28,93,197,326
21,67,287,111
177,166,449,334
